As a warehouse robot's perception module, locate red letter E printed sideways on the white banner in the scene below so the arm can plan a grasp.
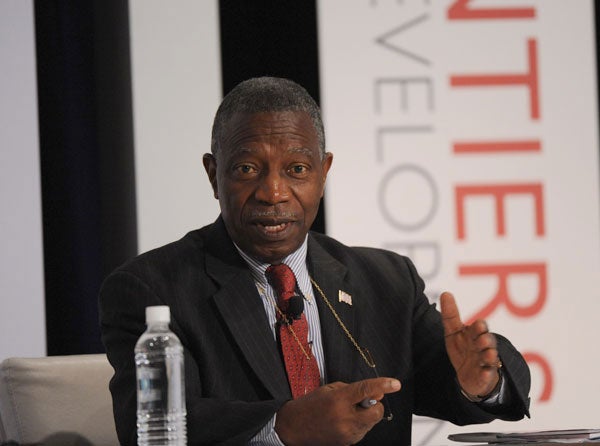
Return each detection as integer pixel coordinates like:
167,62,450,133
455,183,544,240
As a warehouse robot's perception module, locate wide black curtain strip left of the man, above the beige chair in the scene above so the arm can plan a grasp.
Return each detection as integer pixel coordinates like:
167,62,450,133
35,0,137,355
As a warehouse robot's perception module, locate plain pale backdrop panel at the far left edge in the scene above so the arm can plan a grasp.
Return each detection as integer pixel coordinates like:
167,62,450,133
0,0,46,361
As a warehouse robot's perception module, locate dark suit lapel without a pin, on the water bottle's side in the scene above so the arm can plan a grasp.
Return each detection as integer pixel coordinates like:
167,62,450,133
206,219,291,399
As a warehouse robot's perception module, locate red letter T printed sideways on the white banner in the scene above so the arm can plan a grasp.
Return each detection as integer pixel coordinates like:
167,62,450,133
450,39,540,119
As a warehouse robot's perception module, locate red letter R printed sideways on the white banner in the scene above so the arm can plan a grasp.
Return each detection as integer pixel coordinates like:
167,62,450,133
458,263,547,324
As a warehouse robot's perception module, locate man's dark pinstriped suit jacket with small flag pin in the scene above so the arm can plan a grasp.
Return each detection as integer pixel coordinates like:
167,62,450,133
100,218,530,445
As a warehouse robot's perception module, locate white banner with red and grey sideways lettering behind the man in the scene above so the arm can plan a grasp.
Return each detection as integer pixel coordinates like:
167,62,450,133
318,0,600,444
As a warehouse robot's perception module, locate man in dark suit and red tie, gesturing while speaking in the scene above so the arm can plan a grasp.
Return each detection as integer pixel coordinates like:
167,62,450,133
100,78,530,445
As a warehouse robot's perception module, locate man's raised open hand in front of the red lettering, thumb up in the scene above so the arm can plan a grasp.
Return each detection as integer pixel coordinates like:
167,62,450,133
440,292,502,398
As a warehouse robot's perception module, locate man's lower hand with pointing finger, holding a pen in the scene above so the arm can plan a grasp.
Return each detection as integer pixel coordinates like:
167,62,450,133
275,378,400,446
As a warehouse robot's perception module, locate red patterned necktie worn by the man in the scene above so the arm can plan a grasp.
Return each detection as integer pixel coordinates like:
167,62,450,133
265,263,320,398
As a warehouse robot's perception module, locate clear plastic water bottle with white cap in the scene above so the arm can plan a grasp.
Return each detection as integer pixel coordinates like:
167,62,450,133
135,306,187,446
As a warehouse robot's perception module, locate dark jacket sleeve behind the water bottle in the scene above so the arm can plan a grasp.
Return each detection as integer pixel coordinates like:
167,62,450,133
99,271,285,445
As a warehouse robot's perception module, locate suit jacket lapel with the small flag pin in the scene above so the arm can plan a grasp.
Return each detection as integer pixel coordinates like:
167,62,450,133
308,236,360,382
